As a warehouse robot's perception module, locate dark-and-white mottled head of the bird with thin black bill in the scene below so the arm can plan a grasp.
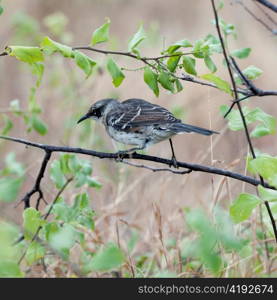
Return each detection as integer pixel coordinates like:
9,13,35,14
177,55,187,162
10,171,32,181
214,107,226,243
77,98,118,123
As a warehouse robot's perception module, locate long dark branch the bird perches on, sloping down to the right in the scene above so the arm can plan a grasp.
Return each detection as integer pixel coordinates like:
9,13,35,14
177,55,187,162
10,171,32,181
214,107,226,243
0,136,275,190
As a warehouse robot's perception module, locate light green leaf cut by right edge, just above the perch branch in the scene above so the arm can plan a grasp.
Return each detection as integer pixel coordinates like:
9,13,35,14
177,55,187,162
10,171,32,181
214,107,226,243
249,156,277,187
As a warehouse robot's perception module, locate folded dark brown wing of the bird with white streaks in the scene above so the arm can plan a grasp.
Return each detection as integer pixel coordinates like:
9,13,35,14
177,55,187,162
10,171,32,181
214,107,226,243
107,99,181,131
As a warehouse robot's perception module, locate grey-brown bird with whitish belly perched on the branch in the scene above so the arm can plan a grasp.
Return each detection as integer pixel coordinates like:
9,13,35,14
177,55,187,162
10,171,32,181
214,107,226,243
77,98,219,167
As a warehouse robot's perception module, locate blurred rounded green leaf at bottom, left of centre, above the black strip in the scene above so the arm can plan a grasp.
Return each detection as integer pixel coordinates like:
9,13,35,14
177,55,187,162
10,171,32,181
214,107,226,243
90,244,125,271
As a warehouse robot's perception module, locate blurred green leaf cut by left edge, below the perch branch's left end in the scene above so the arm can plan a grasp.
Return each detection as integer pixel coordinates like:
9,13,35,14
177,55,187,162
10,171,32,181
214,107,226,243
0,177,23,202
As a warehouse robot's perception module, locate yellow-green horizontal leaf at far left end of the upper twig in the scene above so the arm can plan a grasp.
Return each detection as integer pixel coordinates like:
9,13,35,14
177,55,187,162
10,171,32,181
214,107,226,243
5,46,44,64
